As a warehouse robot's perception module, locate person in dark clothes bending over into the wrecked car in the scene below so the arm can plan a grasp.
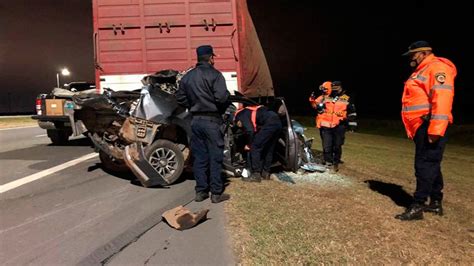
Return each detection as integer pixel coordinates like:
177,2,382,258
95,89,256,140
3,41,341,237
235,106,282,182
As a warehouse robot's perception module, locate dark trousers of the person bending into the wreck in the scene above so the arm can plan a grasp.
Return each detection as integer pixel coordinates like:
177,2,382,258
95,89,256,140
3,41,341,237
250,120,282,173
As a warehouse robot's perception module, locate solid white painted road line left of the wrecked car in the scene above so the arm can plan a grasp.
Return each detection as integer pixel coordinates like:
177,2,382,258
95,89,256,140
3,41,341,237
0,152,98,194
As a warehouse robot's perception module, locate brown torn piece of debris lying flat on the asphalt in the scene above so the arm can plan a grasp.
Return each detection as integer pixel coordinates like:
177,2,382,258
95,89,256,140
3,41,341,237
161,205,209,230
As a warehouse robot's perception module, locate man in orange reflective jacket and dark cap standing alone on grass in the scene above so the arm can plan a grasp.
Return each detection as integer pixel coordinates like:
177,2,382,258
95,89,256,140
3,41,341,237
395,41,457,220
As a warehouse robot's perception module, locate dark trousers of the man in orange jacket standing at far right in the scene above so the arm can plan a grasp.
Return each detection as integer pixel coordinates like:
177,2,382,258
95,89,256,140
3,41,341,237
413,122,447,203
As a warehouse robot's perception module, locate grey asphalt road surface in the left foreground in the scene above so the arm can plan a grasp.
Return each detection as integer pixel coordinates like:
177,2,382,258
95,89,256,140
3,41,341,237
0,128,234,265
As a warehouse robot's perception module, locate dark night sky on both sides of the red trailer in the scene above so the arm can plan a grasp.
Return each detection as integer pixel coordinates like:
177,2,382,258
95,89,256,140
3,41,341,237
0,0,474,122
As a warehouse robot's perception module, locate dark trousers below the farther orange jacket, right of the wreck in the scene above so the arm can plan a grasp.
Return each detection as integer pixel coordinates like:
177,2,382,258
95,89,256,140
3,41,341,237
319,124,346,164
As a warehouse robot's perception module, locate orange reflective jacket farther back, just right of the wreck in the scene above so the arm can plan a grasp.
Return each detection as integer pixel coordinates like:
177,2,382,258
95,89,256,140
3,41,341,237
309,94,349,128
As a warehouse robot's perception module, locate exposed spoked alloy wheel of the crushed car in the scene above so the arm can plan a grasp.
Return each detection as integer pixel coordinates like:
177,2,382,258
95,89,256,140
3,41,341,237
145,139,184,184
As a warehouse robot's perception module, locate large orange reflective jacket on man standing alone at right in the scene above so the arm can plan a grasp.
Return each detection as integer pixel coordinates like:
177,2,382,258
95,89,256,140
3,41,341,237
402,54,457,139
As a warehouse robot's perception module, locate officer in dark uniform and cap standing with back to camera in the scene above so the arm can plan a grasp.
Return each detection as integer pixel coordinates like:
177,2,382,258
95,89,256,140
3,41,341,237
176,45,230,203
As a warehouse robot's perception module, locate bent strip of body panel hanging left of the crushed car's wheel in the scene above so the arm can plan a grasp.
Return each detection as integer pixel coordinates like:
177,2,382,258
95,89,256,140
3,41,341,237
123,143,169,187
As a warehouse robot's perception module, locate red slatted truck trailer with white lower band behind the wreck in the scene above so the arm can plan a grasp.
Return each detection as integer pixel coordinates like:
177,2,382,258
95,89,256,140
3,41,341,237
93,0,274,97
